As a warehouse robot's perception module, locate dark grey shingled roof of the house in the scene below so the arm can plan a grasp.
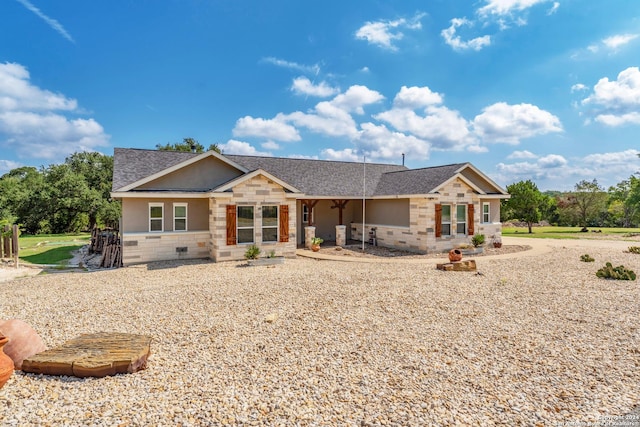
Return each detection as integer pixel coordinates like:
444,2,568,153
113,148,500,198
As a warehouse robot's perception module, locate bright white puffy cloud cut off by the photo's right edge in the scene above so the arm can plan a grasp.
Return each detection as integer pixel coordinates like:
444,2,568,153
582,67,640,126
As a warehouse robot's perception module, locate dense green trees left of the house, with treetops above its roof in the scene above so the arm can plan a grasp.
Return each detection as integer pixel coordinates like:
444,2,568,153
0,138,220,234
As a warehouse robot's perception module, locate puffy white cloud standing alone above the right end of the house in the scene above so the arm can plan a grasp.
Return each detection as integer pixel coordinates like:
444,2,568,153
473,102,562,144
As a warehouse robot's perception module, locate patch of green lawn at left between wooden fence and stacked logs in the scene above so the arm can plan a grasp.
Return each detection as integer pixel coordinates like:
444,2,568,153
18,233,91,265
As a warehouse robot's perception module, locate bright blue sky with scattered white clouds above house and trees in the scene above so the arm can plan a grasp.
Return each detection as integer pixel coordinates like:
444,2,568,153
0,0,640,190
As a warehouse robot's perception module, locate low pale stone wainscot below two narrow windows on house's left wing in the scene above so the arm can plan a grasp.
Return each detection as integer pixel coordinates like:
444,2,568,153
122,231,211,265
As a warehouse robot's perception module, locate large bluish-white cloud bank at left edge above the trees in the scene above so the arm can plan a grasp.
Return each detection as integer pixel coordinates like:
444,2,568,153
0,63,109,160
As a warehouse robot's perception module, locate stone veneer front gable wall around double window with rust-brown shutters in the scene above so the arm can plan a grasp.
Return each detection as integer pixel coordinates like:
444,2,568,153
209,175,296,261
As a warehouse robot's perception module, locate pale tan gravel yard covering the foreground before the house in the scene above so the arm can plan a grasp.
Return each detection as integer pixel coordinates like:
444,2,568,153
0,238,640,426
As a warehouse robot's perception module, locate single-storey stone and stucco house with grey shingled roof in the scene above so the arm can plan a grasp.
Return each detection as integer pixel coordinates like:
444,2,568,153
111,148,509,265
